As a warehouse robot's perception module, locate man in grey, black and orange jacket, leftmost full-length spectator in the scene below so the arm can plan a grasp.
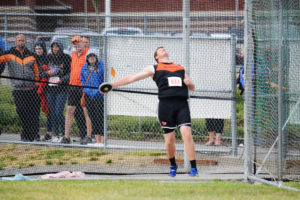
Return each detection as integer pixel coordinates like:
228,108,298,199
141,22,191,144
0,34,40,142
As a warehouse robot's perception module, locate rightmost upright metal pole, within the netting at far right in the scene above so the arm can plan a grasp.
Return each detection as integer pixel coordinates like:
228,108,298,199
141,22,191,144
278,0,284,180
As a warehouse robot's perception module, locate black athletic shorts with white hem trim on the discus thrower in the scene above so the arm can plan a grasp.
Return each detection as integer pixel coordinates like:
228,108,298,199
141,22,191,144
158,97,191,134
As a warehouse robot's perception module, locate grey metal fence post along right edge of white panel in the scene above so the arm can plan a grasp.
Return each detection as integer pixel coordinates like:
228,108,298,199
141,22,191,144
230,34,237,157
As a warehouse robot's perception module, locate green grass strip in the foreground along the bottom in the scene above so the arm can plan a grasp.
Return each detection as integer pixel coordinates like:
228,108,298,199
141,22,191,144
0,181,300,200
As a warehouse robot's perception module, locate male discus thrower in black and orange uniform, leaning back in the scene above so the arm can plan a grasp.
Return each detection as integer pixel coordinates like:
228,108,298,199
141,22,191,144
104,47,198,177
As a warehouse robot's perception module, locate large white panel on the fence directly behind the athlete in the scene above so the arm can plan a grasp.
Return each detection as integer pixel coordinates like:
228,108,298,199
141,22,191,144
107,37,232,118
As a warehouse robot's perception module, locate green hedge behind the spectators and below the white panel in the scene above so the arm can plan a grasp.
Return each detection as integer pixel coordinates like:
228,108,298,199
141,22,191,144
0,86,244,140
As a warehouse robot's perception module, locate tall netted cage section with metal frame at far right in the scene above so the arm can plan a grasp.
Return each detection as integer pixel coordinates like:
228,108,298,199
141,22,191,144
245,0,300,188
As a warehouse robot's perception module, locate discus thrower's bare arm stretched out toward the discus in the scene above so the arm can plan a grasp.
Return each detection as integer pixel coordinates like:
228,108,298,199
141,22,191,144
111,65,154,87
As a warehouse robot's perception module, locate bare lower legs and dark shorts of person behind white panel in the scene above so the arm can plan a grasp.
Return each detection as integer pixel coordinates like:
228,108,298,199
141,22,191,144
205,119,224,146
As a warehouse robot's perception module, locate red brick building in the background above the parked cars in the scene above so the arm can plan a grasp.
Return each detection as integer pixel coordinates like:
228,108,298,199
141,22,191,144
0,0,244,33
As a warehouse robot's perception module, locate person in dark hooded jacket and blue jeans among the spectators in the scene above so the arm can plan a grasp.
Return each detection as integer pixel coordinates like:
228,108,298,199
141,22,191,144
44,41,71,142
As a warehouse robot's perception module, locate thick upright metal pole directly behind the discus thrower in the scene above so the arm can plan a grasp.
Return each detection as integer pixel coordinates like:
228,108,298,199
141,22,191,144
182,0,191,172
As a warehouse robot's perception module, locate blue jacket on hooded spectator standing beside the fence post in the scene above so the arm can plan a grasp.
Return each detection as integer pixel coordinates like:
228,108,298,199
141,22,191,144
80,60,104,99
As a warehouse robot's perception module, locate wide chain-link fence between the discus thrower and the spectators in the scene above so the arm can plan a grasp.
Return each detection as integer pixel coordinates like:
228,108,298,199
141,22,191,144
0,1,243,175
